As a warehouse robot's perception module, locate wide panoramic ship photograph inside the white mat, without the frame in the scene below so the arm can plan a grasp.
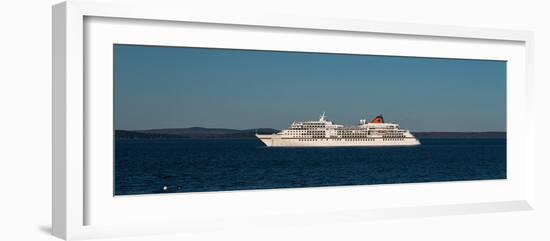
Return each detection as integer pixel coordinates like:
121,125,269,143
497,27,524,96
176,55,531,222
113,44,507,196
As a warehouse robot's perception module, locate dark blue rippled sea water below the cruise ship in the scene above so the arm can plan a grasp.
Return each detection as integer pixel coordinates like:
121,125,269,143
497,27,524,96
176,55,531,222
114,139,506,195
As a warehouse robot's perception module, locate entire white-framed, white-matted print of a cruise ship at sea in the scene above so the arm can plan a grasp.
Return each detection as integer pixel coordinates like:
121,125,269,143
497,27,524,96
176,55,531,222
53,1,534,239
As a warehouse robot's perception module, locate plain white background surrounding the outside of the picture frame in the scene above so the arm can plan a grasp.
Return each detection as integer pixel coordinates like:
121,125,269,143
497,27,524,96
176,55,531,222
0,0,550,240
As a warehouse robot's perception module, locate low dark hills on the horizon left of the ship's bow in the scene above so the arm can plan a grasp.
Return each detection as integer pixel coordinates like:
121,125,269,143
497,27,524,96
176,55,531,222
115,127,278,139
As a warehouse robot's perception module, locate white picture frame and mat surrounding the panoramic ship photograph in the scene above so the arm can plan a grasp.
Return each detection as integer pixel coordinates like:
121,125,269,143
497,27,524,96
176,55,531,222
52,0,535,239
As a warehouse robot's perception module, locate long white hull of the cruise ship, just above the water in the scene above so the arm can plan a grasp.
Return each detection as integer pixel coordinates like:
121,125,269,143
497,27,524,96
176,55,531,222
256,134,420,147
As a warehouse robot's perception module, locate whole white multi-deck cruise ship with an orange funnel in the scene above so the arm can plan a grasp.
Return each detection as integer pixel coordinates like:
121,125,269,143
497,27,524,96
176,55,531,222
256,113,420,147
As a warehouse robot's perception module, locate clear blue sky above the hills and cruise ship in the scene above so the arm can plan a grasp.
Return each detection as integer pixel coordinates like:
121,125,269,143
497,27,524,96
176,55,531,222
114,45,506,131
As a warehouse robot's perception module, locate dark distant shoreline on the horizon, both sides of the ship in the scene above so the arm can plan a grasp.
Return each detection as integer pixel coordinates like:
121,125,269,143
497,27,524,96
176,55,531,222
115,127,506,139
